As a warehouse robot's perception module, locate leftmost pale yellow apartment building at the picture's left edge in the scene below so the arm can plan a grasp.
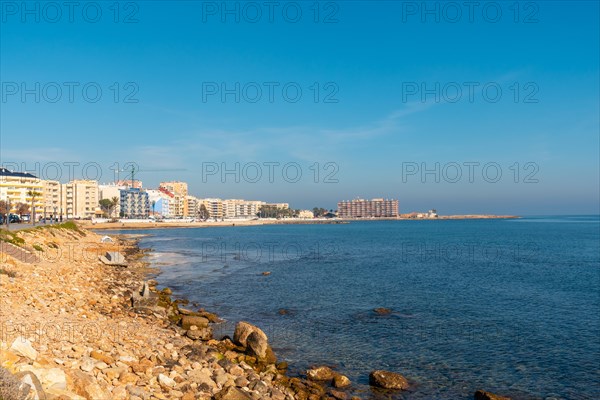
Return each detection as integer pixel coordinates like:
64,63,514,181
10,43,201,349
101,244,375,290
0,168,45,216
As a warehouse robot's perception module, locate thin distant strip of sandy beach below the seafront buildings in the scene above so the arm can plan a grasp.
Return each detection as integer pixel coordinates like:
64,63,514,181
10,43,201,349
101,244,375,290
79,214,521,230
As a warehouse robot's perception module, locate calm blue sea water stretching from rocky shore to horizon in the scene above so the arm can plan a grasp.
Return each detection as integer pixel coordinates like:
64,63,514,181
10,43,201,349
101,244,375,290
105,216,600,399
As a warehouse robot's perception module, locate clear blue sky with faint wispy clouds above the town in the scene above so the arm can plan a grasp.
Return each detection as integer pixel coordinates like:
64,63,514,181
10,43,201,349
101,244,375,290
0,1,600,214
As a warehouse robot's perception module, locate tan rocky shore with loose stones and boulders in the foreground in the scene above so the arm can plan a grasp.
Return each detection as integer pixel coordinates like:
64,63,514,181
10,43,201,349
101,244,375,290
0,223,512,400
